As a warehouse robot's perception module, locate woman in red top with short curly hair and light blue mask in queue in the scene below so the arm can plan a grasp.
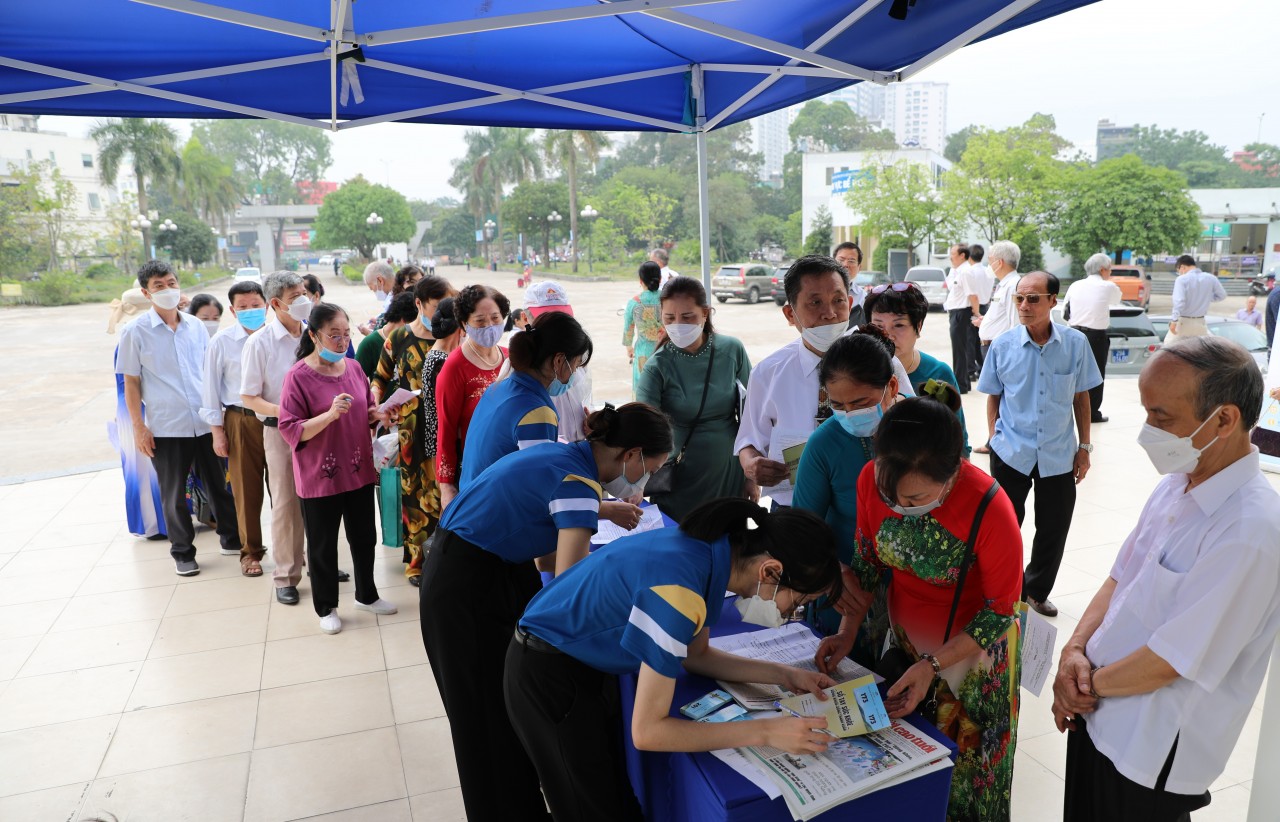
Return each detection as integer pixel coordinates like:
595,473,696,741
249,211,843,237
435,286,511,511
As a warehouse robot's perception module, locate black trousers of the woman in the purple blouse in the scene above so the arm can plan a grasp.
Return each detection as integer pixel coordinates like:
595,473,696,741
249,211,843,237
300,485,378,616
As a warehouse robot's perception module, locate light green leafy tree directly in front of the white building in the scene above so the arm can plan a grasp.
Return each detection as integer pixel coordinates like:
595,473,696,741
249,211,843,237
845,160,956,262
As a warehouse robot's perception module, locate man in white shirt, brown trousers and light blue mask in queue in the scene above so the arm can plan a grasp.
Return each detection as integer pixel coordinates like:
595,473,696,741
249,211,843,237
200,280,266,576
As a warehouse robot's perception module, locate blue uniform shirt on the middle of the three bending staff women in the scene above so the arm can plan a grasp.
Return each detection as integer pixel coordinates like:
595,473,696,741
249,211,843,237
440,440,599,563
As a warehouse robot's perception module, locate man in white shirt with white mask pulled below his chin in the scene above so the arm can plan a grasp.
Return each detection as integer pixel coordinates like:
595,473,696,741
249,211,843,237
733,255,913,506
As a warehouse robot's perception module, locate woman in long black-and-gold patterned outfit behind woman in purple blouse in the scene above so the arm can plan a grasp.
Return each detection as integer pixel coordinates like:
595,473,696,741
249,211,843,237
370,274,453,585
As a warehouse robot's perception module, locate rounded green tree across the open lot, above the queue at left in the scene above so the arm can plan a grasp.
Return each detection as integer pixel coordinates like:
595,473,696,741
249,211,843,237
315,174,417,259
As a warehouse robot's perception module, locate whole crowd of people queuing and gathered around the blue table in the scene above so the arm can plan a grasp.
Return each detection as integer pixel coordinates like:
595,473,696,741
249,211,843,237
107,249,1280,822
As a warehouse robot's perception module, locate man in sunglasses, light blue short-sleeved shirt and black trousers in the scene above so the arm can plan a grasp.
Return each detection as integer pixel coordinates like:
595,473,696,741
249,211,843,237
978,271,1102,616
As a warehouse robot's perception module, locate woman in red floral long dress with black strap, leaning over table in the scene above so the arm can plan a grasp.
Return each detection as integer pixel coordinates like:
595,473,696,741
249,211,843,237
839,397,1023,822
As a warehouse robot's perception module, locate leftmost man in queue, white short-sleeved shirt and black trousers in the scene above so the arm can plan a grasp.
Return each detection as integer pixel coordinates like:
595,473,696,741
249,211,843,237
115,260,241,576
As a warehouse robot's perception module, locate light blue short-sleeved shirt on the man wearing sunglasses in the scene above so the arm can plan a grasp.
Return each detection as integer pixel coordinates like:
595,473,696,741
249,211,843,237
978,323,1102,476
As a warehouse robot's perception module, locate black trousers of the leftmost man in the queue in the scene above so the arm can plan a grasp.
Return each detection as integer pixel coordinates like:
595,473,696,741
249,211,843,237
151,434,241,561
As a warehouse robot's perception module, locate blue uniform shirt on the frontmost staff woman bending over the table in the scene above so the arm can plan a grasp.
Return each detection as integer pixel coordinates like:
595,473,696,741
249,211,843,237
520,528,732,677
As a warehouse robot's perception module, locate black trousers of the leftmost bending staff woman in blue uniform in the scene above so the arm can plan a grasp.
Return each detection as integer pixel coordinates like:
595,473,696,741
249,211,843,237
419,530,549,822
